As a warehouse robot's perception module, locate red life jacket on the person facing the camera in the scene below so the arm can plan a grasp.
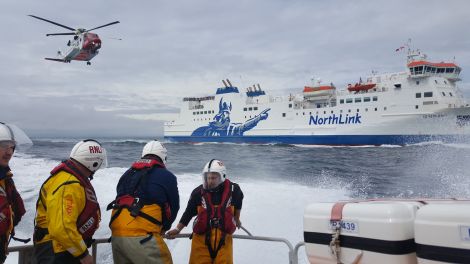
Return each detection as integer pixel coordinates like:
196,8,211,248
193,179,237,234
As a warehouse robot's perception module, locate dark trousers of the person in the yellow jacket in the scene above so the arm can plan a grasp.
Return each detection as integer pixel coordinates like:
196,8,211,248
32,241,80,264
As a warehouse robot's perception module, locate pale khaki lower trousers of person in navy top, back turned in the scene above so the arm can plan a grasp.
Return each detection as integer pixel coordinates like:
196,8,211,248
111,234,173,264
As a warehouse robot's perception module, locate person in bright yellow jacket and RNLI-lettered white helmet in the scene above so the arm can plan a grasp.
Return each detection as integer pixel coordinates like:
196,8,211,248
33,139,107,264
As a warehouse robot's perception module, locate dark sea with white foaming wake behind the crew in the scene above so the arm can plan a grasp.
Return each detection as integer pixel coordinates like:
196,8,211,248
7,138,470,263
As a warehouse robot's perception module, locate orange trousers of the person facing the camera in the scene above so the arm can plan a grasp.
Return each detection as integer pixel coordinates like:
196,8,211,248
189,232,233,264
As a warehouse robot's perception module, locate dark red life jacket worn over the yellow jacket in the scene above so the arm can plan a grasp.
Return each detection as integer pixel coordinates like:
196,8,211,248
35,160,101,243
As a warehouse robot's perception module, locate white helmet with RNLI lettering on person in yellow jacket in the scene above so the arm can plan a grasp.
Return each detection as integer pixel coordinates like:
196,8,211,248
70,139,108,172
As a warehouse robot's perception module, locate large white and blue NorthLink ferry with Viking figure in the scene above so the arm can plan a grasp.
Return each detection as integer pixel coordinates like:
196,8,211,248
164,49,470,145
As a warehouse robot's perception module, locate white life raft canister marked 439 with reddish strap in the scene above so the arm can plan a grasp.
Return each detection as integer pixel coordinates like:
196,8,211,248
304,201,423,264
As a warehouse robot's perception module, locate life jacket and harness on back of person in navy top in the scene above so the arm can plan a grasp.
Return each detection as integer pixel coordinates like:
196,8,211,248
106,159,171,230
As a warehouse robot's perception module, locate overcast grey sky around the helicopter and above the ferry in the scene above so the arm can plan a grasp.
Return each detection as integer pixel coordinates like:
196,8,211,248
0,0,470,138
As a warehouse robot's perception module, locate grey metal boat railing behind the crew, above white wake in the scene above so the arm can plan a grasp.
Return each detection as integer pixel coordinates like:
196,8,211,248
8,232,305,264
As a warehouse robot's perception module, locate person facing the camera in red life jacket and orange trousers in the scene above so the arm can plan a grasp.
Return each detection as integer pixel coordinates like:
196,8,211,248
166,159,243,264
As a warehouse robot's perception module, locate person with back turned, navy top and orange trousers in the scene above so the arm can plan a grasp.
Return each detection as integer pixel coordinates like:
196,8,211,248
108,140,180,264
